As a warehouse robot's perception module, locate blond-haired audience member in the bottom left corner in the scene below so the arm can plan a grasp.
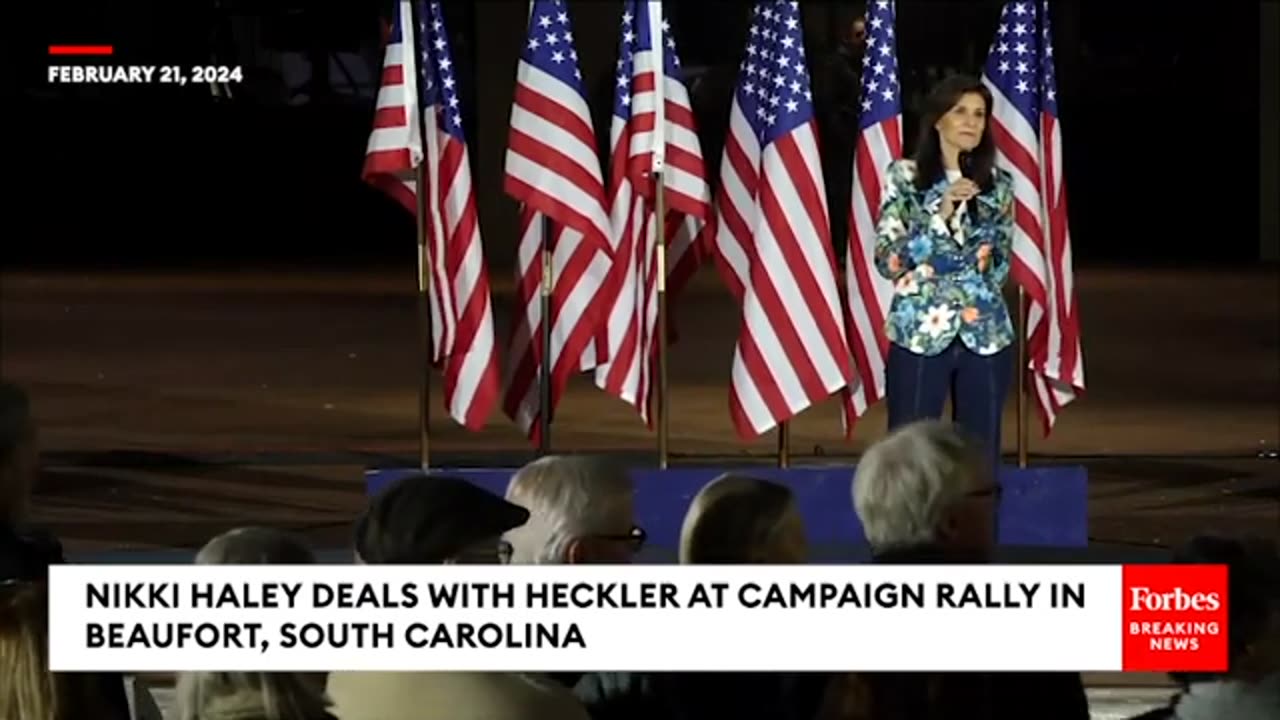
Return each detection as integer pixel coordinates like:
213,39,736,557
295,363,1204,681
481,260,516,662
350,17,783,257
0,582,123,720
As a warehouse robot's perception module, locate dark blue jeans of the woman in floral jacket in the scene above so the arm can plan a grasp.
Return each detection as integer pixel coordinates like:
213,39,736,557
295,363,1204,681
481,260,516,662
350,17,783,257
884,338,1014,471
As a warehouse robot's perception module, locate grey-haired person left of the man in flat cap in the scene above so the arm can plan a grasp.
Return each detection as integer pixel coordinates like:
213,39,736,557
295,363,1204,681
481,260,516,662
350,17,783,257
177,528,333,720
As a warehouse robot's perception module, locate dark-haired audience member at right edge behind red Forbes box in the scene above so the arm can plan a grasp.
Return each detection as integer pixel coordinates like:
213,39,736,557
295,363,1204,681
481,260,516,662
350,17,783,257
1174,536,1280,683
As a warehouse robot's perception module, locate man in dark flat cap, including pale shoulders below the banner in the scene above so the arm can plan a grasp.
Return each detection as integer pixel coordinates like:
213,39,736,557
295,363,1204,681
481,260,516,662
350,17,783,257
328,474,588,720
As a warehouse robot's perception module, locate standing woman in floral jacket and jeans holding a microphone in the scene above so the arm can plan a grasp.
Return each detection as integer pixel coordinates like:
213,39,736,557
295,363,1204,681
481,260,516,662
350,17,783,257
876,76,1014,469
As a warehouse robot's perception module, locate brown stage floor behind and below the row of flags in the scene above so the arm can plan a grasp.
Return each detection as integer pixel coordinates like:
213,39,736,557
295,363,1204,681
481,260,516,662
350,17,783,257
0,269,1280,550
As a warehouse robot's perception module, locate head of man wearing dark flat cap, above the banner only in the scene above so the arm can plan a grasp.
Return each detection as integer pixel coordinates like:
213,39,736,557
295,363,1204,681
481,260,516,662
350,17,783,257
356,473,529,565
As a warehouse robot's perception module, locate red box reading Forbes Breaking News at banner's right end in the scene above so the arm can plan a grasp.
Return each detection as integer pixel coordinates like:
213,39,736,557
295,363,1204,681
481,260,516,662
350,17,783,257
1121,565,1228,673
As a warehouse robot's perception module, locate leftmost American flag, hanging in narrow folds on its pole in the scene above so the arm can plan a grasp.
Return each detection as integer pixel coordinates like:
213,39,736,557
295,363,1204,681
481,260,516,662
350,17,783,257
362,1,500,430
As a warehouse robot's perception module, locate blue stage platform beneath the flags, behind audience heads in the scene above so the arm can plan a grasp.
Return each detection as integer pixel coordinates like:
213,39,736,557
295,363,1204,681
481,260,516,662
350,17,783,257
365,465,1088,561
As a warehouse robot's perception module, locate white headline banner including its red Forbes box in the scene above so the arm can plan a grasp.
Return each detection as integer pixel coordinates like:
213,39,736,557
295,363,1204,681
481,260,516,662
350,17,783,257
49,565,1226,671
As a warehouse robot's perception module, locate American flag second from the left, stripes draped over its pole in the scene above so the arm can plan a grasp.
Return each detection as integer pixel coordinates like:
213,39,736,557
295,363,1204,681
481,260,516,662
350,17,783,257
503,0,614,443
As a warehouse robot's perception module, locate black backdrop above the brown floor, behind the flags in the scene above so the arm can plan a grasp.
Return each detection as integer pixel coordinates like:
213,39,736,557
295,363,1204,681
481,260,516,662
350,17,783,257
4,0,1260,268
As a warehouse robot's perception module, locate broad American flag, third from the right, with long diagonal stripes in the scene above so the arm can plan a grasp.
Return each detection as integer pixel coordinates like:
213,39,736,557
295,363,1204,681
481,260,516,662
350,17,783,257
716,0,851,439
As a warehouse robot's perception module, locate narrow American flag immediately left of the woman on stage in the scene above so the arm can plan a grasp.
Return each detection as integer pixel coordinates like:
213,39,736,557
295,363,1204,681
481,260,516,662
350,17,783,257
844,0,902,433
